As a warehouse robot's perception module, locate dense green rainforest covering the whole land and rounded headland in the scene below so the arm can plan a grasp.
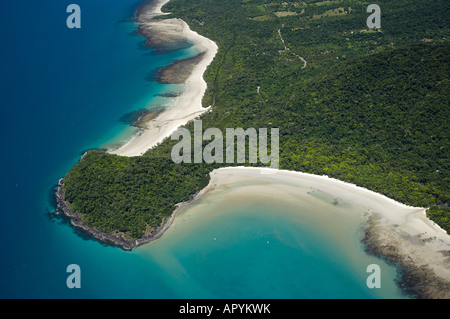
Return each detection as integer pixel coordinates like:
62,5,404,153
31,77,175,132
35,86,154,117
60,0,450,238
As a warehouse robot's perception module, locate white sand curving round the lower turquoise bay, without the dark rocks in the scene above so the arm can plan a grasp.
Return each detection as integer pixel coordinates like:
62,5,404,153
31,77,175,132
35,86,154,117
198,167,450,298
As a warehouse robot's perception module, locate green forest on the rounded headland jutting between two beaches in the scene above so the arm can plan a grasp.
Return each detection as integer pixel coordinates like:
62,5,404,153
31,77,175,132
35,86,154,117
64,151,209,238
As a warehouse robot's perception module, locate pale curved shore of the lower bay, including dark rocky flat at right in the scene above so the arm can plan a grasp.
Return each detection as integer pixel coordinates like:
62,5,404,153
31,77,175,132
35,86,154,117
203,167,450,298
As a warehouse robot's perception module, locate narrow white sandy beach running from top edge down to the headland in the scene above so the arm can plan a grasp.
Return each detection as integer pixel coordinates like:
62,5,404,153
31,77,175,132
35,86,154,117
110,0,218,156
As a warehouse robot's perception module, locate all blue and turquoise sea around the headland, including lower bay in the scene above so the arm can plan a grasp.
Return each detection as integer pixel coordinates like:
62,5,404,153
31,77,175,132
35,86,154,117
0,0,408,298
